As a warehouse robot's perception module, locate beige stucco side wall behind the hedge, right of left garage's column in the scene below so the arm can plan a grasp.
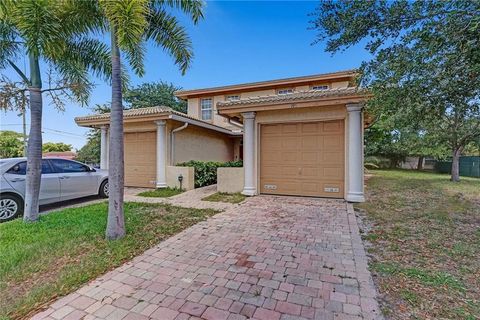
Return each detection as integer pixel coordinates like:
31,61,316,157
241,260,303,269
172,125,234,164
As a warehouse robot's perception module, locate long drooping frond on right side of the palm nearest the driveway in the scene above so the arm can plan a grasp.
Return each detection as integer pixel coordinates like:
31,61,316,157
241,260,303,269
145,9,193,74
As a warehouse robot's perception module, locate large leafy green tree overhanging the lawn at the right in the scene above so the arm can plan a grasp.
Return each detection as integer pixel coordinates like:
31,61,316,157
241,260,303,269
312,0,480,181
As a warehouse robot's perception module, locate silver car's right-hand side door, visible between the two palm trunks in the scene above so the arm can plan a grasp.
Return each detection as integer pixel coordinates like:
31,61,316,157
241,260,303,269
49,159,98,201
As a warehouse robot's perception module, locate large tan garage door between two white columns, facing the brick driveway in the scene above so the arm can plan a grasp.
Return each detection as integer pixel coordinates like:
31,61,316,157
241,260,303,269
260,120,345,198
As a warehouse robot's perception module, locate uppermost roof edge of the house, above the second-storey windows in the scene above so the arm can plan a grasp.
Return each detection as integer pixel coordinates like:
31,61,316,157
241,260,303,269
175,70,358,99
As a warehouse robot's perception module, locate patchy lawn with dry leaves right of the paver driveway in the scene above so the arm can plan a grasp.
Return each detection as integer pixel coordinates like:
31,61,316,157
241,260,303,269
356,170,480,320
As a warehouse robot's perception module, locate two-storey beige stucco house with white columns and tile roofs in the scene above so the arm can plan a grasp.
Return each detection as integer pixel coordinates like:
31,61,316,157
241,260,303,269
75,71,367,202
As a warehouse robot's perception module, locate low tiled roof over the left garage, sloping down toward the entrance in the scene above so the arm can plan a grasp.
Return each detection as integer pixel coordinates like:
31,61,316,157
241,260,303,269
75,106,240,135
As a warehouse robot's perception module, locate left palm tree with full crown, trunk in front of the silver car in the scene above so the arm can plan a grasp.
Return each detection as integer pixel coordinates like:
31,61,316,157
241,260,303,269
0,0,110,222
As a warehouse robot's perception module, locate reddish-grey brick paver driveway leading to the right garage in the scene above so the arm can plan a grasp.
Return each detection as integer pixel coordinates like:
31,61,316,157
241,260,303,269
34,196,380,320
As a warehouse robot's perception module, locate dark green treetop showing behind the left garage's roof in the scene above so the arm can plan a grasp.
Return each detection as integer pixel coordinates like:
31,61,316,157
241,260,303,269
123,81,187,113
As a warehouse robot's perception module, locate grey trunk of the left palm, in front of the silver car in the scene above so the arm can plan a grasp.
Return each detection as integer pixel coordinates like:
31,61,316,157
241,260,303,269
23,54,43,222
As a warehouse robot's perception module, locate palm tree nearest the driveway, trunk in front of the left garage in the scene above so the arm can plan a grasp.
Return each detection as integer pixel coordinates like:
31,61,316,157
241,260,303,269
99,0,203,239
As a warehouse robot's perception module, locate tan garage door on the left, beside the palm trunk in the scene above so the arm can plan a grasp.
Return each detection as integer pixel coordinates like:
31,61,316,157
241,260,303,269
124,132,156,188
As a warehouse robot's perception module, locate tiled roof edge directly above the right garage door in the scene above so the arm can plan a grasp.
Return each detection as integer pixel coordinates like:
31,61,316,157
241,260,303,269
217,87,366,107
